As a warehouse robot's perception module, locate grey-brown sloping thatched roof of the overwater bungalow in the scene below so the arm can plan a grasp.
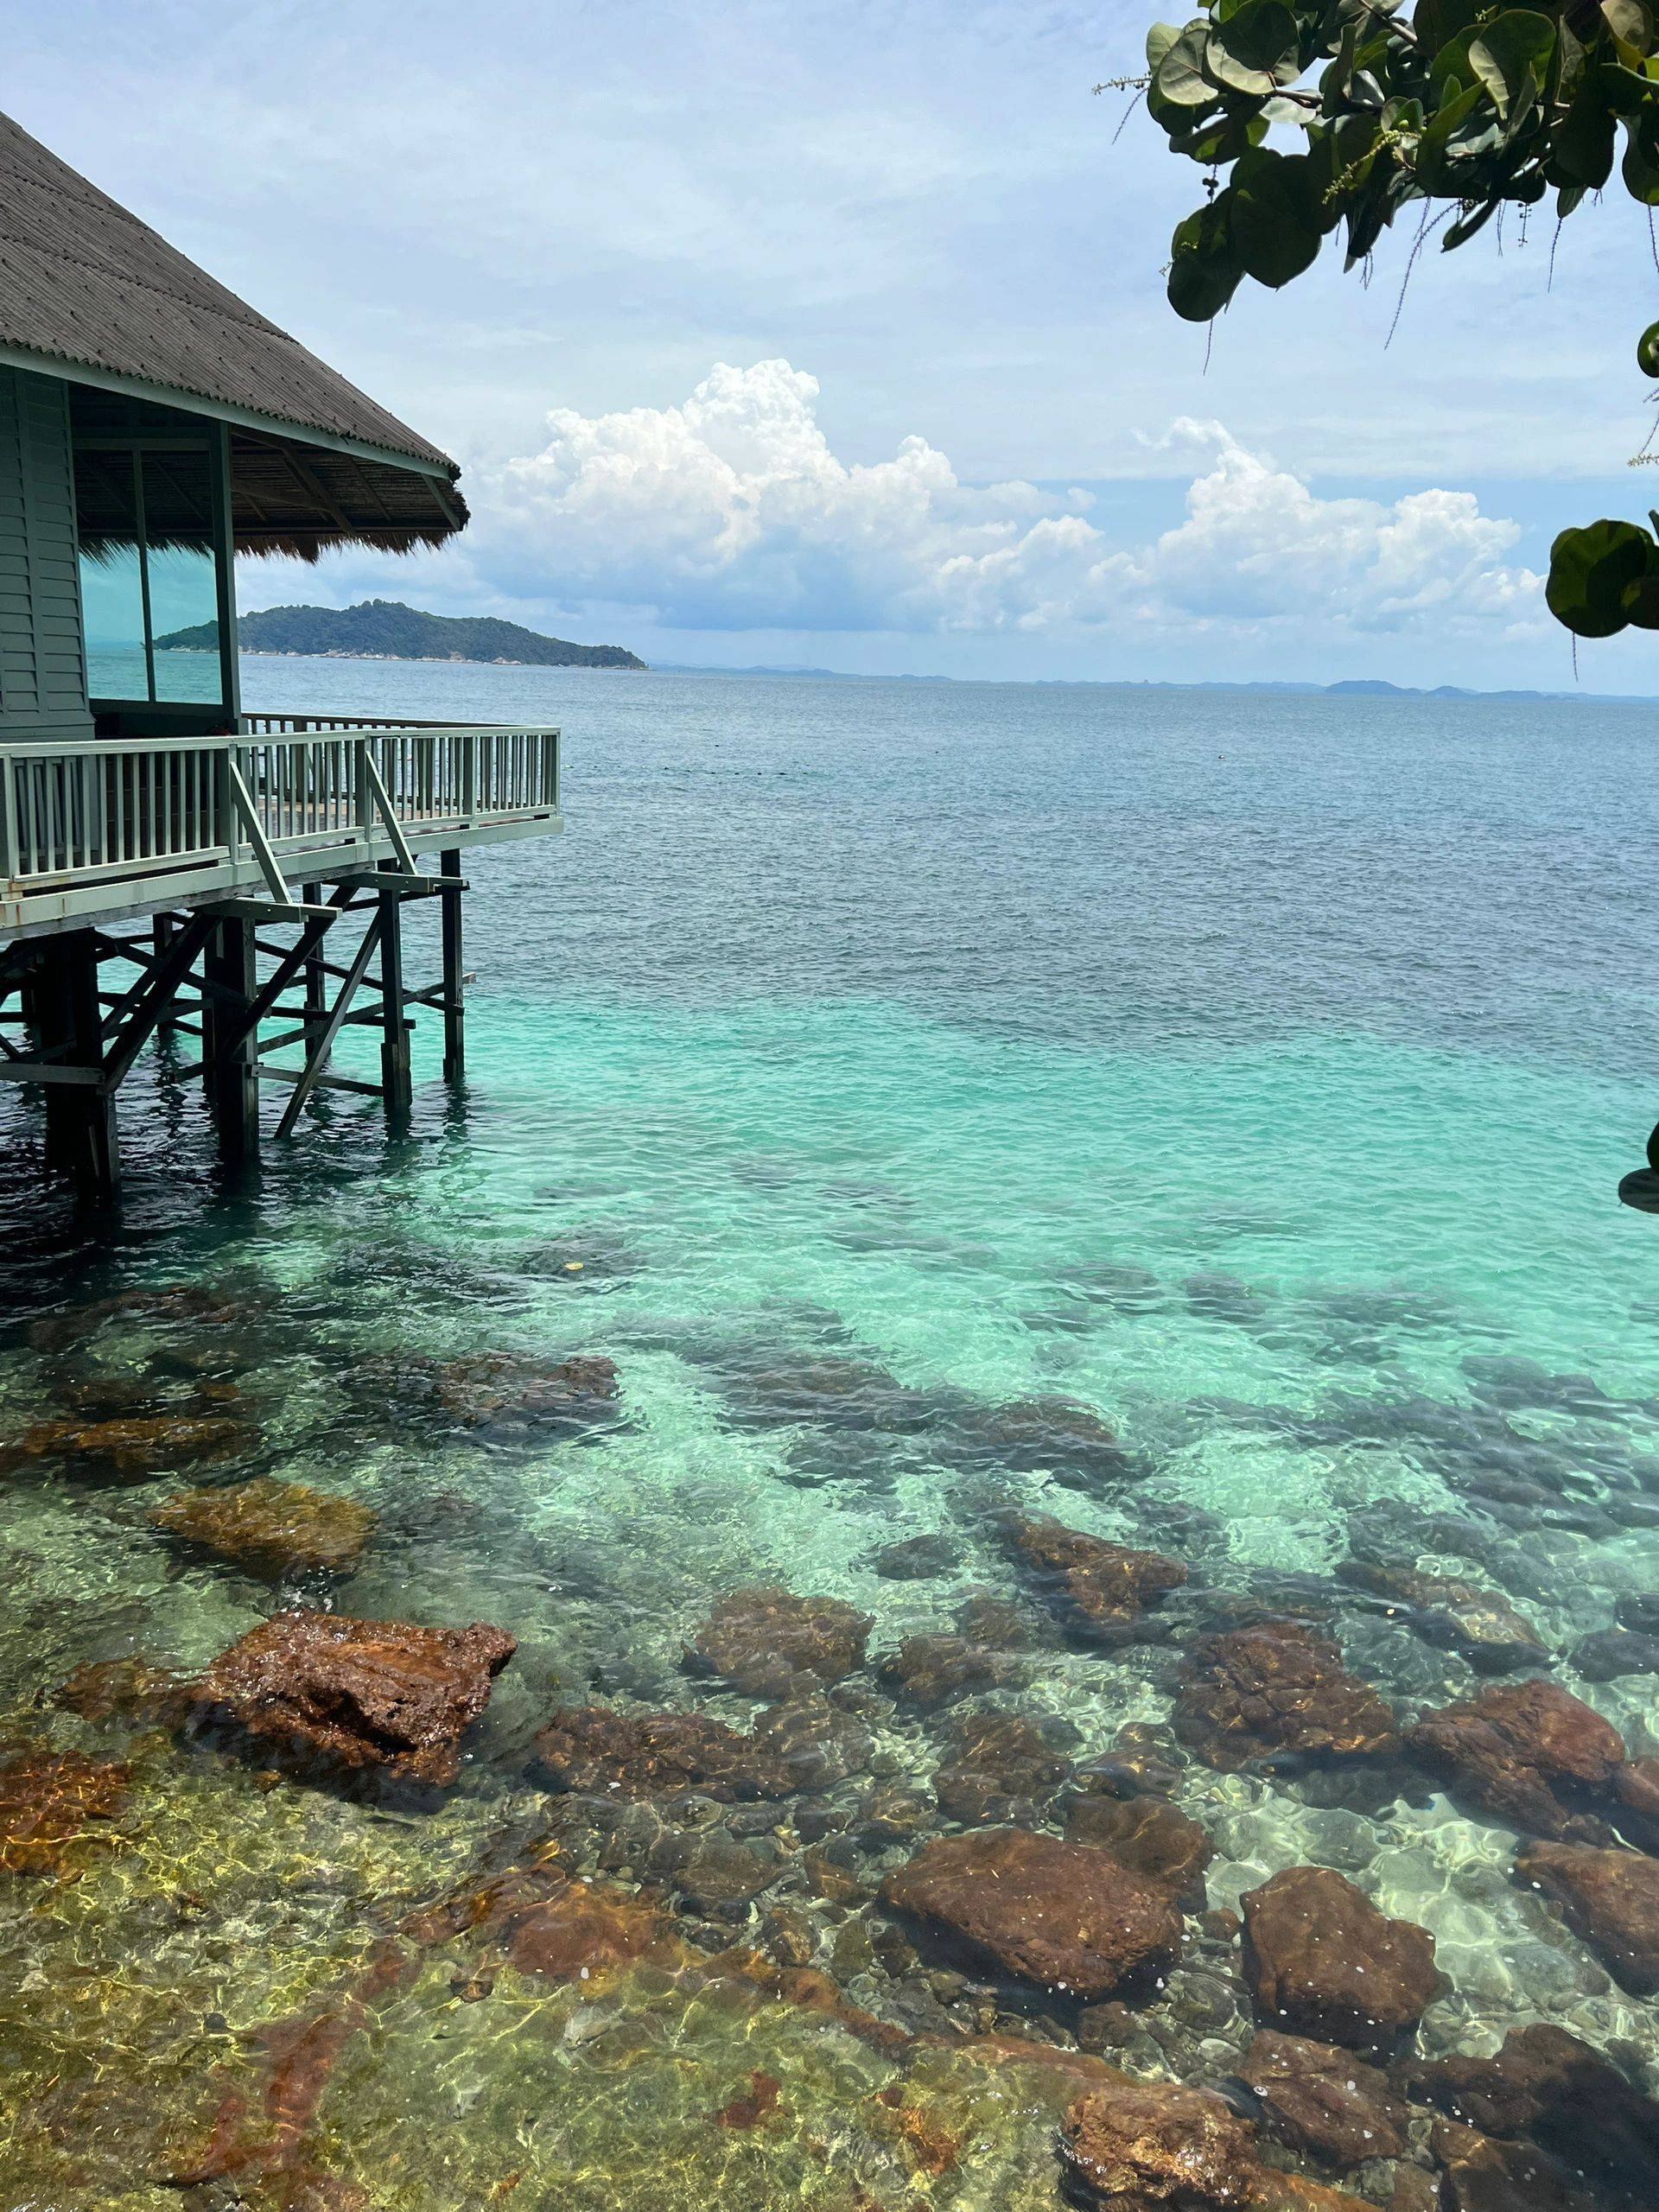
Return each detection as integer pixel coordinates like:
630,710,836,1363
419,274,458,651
0,115,467,557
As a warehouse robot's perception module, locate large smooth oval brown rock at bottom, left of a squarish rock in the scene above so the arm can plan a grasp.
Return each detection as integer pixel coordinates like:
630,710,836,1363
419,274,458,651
880,1827,1181,1998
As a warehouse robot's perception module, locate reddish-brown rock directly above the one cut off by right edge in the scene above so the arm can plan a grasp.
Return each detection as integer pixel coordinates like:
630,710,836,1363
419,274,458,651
1407,1681,1624,1842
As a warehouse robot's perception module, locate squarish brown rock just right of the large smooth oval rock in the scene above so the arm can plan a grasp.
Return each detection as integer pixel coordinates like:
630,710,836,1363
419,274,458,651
1241,1867,1445,2050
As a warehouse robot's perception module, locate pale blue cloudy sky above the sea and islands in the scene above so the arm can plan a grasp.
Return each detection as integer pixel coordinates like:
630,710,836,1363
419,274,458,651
13,0,1659,692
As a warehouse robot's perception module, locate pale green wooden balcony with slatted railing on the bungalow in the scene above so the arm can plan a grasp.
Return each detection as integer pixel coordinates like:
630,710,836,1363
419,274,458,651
0,715,562,938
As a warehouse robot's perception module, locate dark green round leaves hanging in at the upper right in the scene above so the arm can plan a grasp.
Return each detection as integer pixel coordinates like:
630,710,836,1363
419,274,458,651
1146,0,1659,637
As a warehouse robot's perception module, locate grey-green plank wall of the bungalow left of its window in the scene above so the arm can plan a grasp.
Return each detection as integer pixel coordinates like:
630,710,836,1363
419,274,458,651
0,367,93,741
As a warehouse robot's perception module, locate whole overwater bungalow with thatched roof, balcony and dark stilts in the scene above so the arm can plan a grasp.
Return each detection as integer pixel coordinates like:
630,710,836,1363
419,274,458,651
0,118,560,1192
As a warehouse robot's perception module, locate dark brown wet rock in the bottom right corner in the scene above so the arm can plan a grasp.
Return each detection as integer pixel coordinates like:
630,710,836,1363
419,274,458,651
1409,2026,1659,2205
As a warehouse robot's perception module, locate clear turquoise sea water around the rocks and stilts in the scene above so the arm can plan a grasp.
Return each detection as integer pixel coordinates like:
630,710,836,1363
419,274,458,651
0,659,1659,2212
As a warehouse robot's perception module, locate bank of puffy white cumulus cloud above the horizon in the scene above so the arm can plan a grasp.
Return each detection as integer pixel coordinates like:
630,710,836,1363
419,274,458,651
471,360,1541,637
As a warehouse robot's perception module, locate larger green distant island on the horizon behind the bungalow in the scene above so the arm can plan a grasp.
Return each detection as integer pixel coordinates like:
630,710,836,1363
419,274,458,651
155,600,646,668
